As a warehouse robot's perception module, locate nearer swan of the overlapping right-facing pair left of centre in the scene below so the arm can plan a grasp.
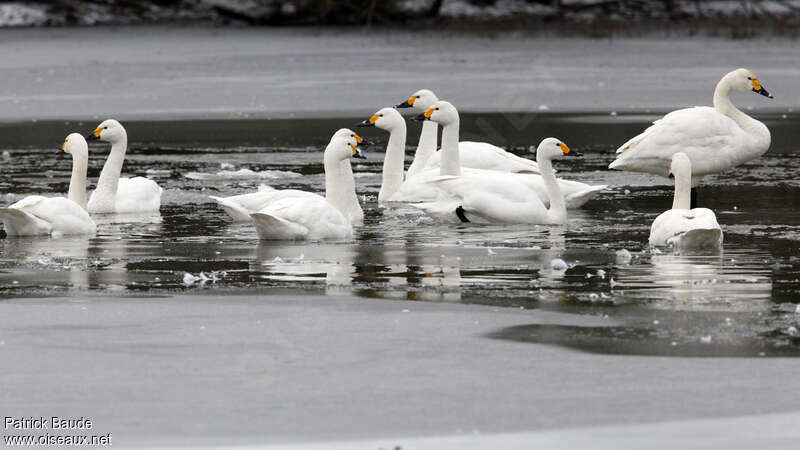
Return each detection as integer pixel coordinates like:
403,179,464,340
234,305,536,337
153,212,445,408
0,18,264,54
250,138,364,240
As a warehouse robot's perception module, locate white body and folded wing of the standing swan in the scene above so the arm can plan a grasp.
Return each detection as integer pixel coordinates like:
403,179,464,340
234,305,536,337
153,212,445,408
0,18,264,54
608,106,752,176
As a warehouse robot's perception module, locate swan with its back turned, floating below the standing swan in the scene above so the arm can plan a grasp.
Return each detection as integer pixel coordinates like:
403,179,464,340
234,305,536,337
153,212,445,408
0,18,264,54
650,152,722,250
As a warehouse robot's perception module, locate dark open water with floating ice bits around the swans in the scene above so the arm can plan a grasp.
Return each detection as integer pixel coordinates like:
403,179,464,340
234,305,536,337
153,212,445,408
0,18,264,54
0,114,800,356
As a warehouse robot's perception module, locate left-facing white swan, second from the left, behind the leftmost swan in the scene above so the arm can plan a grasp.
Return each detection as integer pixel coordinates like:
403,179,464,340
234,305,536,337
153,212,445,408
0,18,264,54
86,119,163,214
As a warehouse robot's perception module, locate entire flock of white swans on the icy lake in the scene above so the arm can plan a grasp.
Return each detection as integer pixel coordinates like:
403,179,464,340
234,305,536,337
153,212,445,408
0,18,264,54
0,69,772,255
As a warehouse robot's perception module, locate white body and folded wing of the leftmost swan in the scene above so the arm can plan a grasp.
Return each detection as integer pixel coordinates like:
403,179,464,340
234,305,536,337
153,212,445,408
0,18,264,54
0,195,97,236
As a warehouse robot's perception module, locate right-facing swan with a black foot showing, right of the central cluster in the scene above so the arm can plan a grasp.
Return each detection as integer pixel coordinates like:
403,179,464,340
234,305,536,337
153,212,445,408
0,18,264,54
413,135,580,224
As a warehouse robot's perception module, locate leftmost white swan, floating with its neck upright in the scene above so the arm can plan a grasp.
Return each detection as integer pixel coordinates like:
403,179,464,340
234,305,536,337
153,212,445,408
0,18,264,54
0,133,97,237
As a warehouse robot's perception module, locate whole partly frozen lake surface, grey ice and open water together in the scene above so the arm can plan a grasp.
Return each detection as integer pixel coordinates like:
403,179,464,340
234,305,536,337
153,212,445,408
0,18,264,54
0,28,800,449
